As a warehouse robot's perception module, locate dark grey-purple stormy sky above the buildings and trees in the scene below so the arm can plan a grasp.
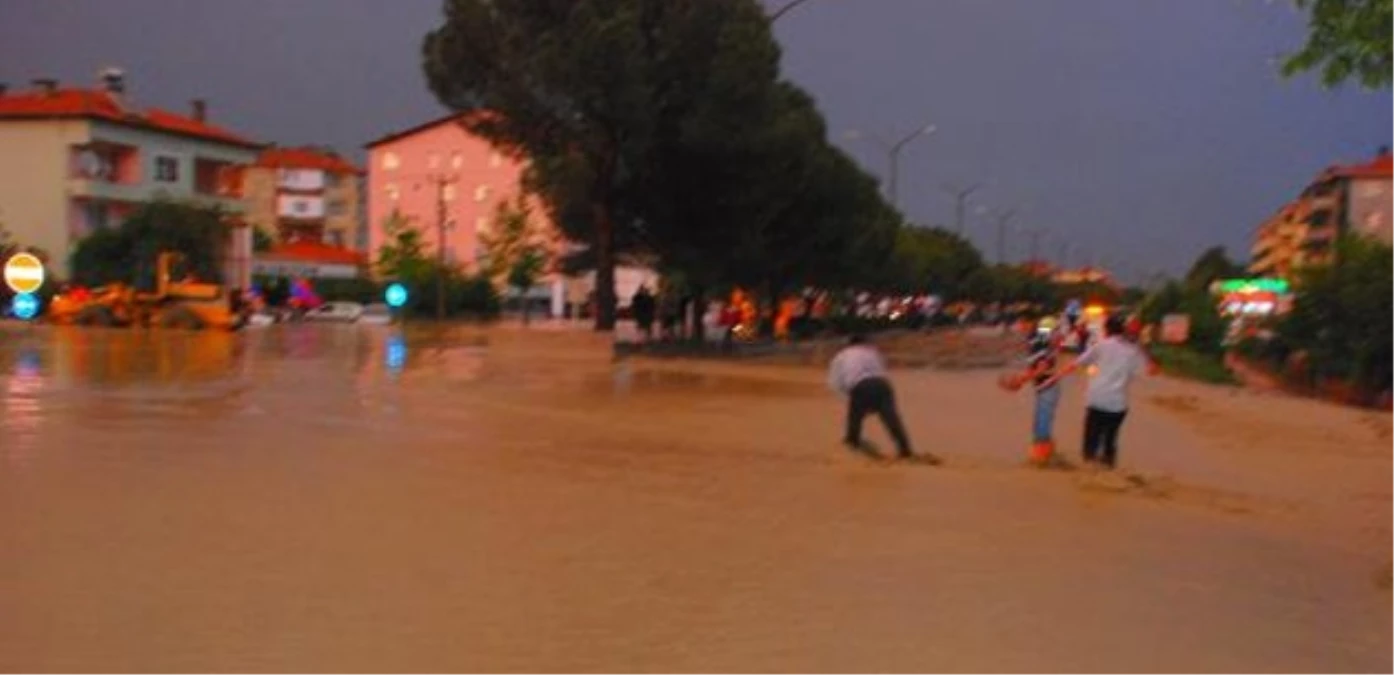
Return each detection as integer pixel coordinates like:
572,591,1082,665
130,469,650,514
0,0,1394,278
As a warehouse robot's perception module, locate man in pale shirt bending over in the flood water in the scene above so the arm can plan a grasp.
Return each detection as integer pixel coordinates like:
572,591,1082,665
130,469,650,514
828,335,938,464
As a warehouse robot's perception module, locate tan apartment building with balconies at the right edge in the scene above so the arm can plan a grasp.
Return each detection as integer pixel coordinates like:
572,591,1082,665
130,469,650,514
1249,148,1394,279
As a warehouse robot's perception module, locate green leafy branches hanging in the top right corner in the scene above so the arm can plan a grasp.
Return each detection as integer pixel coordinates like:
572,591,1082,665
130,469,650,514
1282,0,1394,89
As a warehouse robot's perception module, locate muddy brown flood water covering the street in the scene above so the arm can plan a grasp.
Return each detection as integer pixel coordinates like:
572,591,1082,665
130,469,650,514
0,325,1394,675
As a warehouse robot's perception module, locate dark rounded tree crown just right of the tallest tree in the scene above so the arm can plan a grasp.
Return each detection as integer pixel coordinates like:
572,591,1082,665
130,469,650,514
644,76,898,300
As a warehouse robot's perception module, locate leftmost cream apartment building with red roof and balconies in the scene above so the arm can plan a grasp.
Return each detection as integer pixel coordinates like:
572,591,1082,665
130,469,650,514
0,70,259,286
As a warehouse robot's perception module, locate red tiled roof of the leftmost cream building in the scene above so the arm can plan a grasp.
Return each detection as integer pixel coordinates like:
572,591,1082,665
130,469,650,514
0,88,261,148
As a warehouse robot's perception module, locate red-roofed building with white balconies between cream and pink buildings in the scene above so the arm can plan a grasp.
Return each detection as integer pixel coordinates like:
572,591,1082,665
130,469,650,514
244,146,365,276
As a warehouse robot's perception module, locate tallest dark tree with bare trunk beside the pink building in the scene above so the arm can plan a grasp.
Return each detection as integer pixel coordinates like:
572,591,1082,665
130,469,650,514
424,0,778,331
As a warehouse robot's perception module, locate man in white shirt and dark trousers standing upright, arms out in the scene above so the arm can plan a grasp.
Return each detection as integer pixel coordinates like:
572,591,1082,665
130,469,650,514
1050,317,1157,469
